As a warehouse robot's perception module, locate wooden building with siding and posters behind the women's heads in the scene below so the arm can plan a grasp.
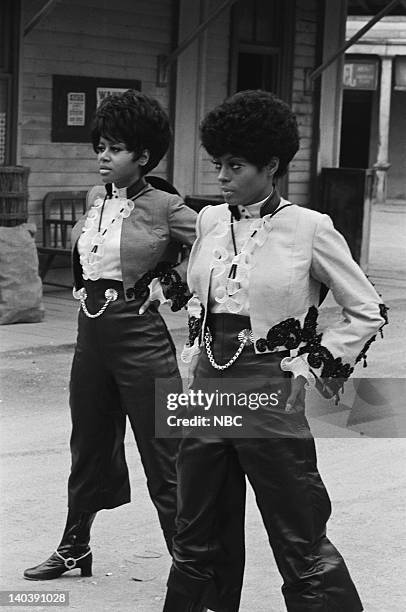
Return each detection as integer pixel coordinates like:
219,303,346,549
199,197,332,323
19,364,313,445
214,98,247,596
0,0,404,240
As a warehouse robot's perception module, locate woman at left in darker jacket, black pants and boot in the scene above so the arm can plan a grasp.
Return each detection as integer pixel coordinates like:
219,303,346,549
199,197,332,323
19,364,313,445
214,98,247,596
24,90,196,580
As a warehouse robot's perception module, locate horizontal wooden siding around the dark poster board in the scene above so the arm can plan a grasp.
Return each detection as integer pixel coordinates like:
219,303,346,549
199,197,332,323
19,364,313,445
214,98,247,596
20,0,173,230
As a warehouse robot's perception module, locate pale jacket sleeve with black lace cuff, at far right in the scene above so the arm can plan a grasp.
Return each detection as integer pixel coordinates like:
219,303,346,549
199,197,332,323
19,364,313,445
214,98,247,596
299,215,387,396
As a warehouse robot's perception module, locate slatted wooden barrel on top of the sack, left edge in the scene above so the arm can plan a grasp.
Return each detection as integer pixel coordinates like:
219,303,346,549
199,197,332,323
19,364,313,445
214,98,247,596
0,166,30,227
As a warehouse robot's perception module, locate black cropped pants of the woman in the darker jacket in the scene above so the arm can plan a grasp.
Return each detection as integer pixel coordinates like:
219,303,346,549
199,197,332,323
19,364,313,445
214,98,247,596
68,280,181,550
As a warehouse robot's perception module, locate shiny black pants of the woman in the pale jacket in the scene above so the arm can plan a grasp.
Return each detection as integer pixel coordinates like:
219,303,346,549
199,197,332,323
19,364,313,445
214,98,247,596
168,315,362,612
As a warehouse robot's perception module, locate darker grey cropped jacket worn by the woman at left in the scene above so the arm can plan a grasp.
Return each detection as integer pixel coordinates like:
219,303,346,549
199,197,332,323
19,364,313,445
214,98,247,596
71,185,196,301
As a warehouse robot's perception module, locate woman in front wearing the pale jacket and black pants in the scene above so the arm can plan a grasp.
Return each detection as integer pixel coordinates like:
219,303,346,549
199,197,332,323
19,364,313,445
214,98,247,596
164,91,386,612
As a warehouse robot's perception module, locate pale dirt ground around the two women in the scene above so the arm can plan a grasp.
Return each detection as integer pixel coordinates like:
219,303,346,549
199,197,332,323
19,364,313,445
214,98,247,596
0,203,406,612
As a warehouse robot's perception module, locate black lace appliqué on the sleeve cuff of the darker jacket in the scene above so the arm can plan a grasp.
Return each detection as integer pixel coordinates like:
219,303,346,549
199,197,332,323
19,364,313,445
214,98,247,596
134,261,190,312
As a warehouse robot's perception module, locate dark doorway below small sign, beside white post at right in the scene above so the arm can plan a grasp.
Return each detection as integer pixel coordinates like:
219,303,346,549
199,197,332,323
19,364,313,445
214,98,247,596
340,89,373,168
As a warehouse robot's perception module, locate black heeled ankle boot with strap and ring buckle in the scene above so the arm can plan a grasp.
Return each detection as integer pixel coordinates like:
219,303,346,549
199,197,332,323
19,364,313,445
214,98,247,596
24,510,96,580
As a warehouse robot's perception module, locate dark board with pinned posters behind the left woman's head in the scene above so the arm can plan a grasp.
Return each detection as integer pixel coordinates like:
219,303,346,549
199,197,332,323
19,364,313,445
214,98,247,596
51,75,141,143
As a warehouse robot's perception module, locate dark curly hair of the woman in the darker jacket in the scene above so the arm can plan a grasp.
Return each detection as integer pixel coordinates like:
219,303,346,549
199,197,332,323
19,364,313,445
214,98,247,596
91,89,172,174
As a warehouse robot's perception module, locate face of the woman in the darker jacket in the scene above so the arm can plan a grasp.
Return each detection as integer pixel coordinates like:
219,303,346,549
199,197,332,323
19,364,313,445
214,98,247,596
97,137,148,188
